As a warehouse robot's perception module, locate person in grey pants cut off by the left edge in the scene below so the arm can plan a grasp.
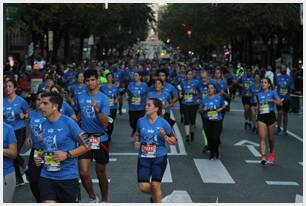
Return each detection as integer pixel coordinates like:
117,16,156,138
3,122,17,203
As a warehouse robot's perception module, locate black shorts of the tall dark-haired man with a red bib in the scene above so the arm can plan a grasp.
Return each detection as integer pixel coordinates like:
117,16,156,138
79,142,109,165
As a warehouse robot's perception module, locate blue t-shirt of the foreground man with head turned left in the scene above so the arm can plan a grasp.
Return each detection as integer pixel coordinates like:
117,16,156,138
40,115,82,180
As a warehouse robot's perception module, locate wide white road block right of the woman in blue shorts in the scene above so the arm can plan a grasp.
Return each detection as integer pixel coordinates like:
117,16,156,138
194,159,235,184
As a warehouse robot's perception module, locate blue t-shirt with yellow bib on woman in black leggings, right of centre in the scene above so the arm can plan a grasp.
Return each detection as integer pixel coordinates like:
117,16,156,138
199,95,226,121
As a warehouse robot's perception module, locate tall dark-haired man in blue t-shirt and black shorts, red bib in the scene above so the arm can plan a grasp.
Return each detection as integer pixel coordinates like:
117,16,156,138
77,69,110,203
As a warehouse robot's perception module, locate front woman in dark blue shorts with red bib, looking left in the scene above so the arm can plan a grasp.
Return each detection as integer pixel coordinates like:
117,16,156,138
134,98,176,203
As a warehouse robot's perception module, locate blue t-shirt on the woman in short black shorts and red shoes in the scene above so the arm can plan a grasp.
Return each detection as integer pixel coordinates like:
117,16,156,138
258,90,280,114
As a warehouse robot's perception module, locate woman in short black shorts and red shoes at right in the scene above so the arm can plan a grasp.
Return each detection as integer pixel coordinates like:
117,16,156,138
257,78,283,165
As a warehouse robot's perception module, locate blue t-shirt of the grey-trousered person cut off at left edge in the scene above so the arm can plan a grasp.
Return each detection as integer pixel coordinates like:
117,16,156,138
3,122,17,176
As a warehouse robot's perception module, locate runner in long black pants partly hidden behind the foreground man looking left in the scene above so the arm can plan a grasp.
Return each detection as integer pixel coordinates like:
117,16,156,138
26,92,46,202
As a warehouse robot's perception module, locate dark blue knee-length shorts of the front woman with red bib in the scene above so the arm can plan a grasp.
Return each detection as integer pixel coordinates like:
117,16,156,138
137,155,167,182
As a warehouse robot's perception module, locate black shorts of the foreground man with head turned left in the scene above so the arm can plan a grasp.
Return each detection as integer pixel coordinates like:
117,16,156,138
38,177,81,203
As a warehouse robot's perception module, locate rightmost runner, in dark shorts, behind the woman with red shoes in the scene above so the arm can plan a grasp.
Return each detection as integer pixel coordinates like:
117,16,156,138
275,64,294,135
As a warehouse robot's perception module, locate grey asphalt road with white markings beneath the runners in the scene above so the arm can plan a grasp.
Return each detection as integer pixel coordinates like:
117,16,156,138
14,98,303,203
